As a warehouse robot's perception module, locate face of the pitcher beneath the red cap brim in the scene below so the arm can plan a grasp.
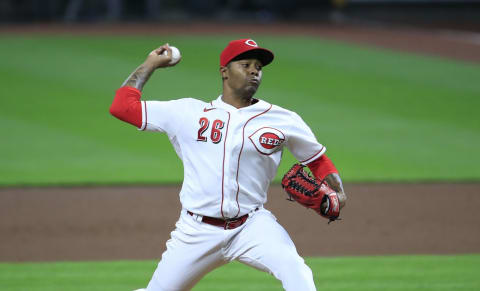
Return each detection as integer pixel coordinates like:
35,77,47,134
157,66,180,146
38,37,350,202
224,59,262,96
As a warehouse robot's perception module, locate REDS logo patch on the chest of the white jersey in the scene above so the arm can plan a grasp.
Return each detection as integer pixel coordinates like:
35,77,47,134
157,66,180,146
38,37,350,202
248,127,285,155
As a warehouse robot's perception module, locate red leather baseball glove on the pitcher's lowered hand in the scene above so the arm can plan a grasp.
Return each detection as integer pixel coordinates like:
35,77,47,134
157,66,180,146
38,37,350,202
282,164,340,223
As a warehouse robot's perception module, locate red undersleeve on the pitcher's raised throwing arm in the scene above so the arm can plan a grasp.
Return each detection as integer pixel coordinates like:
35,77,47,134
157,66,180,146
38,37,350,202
110,86,142,128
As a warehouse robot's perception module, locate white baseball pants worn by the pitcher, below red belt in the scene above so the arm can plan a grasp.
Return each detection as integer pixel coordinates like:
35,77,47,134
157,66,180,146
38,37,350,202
147,208,316,291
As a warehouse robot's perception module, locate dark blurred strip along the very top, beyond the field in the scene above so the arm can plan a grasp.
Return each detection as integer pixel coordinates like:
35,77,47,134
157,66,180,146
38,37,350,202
0,0,480,31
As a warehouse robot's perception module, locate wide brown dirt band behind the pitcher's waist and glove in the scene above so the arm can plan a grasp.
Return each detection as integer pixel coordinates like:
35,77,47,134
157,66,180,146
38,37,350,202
0,184,480,261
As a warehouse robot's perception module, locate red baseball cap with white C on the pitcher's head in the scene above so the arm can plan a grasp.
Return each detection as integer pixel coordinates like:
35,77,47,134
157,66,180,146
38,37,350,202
220,38,273,67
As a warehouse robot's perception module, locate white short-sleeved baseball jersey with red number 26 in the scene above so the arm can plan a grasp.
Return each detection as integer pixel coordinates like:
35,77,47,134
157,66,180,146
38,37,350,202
141,96,325,218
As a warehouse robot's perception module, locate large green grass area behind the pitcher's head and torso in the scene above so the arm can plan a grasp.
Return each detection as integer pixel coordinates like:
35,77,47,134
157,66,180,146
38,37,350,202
0,35,480,186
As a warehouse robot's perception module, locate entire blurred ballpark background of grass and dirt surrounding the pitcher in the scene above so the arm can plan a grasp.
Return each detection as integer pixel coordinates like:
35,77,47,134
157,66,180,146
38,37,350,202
0,0,480,291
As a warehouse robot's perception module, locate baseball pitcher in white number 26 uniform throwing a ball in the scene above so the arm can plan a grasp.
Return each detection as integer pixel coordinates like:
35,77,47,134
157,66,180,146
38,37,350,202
110,39,346,291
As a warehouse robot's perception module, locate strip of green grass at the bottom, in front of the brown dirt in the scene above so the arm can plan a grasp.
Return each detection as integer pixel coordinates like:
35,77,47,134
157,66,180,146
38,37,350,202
0,255,480,291
